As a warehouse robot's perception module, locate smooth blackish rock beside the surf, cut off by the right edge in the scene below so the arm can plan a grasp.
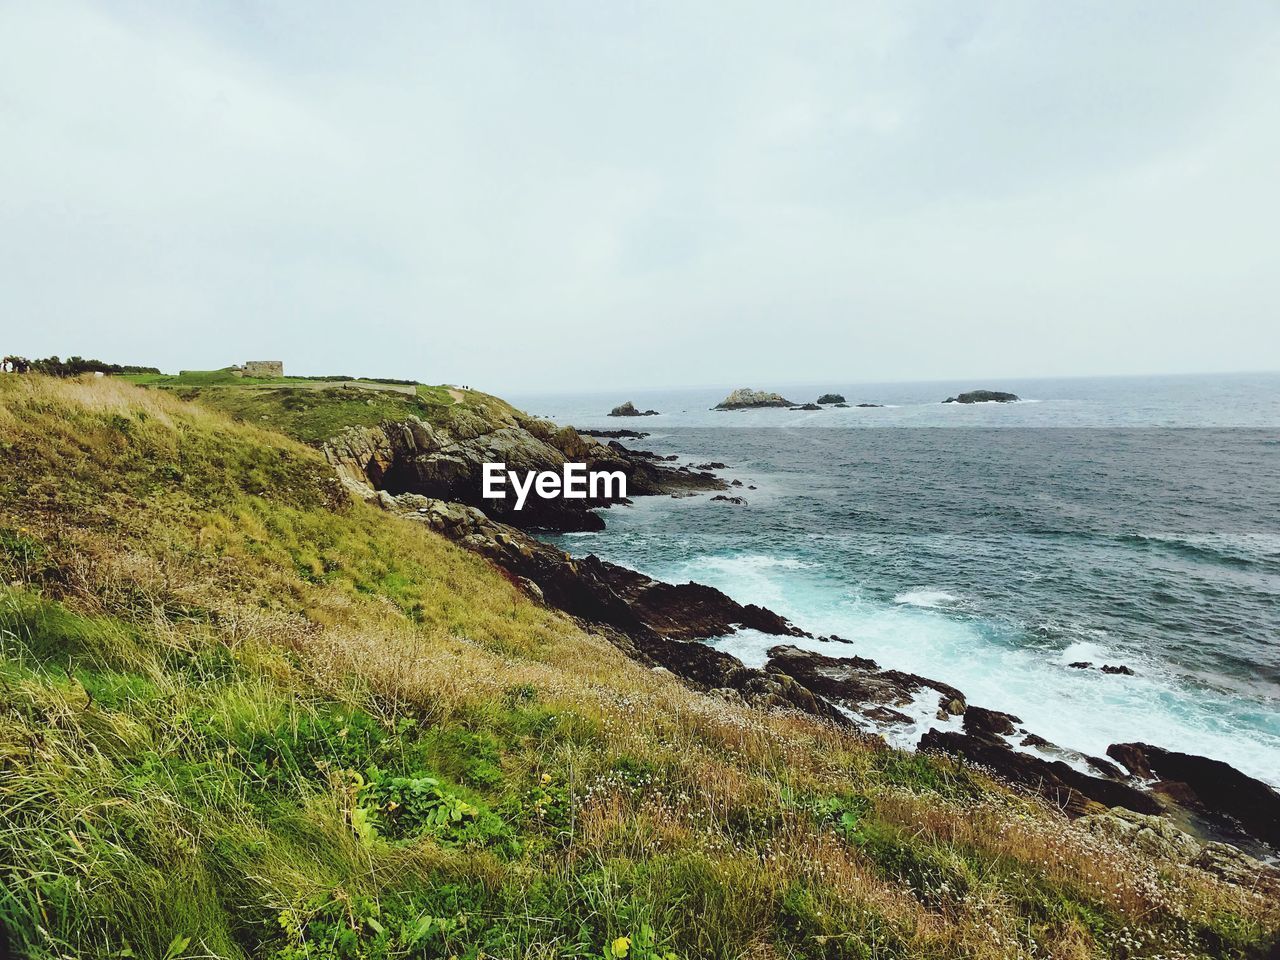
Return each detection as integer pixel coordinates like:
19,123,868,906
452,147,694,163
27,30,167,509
1107,744,1280,846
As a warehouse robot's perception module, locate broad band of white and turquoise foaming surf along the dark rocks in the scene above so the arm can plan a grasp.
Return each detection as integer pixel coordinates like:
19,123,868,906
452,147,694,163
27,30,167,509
700,586,1280,787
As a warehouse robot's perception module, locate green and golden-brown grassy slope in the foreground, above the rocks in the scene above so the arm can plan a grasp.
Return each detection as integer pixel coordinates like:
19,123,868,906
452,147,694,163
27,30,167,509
0,376,1280,960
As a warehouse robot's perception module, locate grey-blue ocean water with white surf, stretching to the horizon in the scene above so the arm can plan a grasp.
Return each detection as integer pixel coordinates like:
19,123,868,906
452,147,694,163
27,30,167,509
512,375,1280,786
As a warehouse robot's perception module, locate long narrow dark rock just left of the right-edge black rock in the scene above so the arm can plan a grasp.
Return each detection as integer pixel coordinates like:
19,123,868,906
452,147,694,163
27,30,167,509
919,732,1161,817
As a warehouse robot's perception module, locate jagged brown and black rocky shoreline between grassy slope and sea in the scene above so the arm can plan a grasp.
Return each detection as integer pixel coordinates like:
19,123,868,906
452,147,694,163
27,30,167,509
324,417,1280,876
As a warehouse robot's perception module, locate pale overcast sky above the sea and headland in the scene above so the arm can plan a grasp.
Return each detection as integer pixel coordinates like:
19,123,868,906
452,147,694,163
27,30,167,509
0,0,1280,393
